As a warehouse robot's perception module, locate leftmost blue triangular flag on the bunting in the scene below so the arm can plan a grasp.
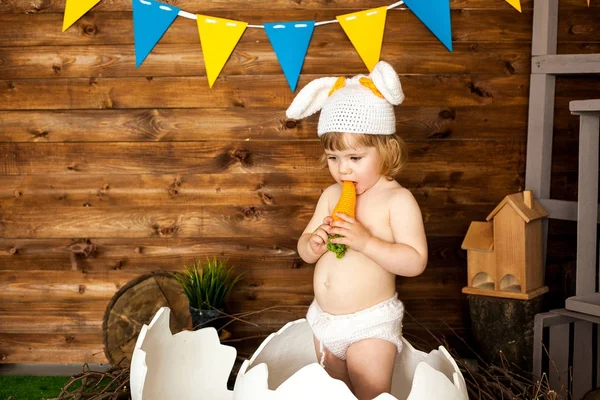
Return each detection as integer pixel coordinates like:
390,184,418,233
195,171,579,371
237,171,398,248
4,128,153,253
133,0,180,68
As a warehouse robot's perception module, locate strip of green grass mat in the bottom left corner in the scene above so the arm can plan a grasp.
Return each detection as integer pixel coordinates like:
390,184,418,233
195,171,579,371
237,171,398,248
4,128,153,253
0,376,71,400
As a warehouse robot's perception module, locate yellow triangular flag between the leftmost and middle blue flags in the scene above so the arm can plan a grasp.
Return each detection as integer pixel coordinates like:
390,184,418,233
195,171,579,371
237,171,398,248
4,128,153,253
196,15,248,88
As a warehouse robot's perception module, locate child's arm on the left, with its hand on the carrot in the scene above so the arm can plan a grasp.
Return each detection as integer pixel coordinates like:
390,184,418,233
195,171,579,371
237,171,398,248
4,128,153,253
298,185,335,264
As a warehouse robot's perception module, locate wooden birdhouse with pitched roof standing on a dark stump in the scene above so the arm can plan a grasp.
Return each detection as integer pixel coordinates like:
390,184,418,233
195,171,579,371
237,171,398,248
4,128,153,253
461,191,548,300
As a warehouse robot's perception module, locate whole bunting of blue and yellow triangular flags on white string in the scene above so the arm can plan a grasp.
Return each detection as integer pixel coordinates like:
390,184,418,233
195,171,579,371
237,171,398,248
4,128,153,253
63,0,590,91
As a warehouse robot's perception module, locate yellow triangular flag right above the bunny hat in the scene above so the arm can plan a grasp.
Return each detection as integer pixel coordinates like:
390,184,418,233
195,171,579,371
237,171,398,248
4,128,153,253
336,6,387,71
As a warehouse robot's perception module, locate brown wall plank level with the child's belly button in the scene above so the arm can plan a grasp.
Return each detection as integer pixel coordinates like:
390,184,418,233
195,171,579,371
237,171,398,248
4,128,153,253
0,266,463,304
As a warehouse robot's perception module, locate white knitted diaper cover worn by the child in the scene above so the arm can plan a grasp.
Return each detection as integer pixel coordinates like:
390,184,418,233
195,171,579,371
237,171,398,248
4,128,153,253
306,293,404,366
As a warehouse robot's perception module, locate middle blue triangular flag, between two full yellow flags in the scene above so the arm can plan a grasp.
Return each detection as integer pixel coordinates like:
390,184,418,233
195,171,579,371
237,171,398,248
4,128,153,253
264,21,315,92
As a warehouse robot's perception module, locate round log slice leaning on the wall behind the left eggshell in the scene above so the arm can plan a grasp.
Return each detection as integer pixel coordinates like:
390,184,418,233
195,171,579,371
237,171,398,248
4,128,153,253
102,271,192,366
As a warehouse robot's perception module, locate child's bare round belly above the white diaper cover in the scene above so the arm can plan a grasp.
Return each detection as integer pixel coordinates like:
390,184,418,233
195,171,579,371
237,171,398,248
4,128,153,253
313,250,396,315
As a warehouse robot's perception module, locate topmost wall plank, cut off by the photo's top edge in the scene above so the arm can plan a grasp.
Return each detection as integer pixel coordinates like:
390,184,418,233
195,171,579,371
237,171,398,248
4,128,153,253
0,0,597,14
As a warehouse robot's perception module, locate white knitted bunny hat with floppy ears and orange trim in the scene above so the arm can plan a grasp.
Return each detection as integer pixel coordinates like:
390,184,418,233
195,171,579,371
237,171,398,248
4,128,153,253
286,61,404,136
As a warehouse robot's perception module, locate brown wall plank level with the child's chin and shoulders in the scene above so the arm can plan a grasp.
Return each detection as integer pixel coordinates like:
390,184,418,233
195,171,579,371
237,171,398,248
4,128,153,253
0,170,524,209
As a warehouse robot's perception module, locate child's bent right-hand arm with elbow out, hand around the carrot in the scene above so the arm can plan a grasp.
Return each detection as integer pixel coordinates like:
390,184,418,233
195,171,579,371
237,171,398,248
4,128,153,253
332,189,427,276
